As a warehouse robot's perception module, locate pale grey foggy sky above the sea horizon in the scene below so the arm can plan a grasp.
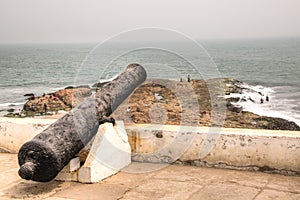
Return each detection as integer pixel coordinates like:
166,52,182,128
0,0,300,43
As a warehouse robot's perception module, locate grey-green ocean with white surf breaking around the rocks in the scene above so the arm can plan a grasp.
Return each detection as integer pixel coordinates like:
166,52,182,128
0,38,300,125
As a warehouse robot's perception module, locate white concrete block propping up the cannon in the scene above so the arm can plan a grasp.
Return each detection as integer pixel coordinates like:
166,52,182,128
78,121,131,183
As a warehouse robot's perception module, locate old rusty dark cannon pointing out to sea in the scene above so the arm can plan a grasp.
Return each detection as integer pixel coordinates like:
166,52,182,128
18,64,147,182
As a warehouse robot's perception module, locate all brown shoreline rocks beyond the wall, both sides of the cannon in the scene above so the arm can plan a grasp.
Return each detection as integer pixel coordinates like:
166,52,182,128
7,78,300,131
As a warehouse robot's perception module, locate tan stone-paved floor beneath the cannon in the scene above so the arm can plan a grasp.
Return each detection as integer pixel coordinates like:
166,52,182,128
0,153,300,200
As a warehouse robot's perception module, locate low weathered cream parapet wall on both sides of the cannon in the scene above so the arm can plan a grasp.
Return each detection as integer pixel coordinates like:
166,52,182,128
0,118,300,175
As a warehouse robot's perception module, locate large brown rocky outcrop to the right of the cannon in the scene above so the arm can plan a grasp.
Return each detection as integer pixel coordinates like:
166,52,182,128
114,78,300,131
